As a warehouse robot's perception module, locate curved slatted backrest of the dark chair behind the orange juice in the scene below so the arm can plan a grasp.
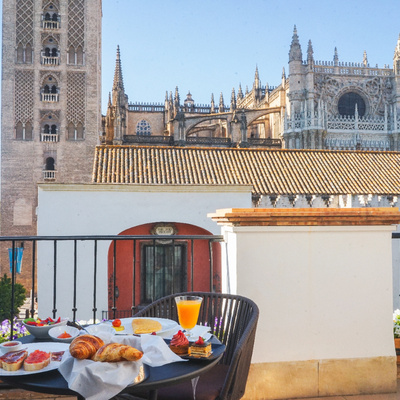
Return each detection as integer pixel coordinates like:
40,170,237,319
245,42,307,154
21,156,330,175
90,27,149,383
135,292,259,399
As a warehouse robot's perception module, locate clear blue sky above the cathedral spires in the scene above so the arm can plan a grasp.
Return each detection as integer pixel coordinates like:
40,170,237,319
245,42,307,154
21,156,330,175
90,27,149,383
102,0,400,112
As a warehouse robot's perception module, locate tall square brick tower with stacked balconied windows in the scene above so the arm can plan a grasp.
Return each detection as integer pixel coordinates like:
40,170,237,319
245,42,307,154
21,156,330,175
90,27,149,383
1,0,101,283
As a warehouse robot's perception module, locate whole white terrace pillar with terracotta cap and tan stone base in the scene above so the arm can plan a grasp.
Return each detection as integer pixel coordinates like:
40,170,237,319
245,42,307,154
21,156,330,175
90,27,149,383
209,208,400,400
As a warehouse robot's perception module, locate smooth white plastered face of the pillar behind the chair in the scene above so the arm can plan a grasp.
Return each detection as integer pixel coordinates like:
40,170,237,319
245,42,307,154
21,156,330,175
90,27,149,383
224,226,394,363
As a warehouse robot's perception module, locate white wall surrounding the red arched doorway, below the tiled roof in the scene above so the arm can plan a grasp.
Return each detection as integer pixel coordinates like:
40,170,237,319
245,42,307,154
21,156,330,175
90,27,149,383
37,184,251,320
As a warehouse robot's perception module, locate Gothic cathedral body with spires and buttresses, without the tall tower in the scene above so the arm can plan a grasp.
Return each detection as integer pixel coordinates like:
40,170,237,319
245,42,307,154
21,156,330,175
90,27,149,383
101,27,400,151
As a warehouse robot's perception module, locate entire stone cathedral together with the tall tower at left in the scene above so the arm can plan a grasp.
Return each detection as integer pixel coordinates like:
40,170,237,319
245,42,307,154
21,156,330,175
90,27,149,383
1,0,400,290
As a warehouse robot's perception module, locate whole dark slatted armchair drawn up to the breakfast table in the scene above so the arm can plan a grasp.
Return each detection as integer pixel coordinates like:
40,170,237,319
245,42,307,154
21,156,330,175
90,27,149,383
118,292,259,400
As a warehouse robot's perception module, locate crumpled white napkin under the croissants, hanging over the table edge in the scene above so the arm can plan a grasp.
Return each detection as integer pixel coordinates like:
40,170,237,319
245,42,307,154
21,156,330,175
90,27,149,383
58,335,185,400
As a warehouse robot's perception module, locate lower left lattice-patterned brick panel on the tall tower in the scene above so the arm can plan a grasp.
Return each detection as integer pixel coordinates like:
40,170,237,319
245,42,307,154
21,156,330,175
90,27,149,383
15,70,35,123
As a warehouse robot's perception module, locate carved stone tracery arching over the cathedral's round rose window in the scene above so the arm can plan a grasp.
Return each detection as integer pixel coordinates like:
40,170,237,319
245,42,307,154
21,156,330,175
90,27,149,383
314,74,393,116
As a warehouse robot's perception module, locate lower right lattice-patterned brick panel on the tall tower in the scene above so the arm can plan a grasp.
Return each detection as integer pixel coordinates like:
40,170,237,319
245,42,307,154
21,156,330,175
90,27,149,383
67,72,86,125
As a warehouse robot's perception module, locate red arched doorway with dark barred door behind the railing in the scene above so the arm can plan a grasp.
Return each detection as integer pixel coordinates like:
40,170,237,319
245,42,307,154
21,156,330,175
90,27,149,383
108,222,221,318
